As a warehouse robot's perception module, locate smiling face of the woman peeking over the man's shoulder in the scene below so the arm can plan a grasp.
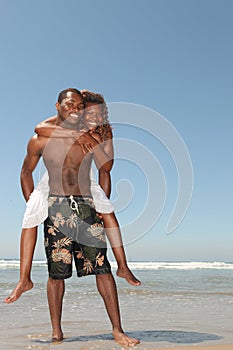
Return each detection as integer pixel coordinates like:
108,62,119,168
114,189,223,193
83,102,103,129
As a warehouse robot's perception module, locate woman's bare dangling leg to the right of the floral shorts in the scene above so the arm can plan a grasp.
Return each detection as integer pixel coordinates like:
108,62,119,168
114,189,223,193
101,213,141,286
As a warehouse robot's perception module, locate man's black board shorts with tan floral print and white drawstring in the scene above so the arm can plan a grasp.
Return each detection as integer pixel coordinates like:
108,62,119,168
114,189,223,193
44,195,111,279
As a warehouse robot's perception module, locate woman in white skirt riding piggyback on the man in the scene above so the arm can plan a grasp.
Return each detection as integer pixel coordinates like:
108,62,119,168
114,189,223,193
4,90,141,304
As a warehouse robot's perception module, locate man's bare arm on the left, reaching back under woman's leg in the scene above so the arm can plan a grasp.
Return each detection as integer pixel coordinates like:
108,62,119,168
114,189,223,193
20,136,42,201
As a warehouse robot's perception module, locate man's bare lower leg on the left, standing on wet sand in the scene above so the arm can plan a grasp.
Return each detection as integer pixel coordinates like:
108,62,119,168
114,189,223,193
47,278,65,342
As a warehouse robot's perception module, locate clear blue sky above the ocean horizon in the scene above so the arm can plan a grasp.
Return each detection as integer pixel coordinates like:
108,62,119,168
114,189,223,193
0,0,233,261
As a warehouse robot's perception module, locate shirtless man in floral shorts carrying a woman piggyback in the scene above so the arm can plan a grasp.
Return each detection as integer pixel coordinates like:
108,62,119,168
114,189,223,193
21,89,139,346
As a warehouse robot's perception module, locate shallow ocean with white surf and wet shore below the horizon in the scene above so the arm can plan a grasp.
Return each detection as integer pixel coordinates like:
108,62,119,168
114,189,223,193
0,260,233,350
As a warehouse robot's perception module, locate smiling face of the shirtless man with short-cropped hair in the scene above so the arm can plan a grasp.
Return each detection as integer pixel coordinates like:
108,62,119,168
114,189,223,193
56,91,84,128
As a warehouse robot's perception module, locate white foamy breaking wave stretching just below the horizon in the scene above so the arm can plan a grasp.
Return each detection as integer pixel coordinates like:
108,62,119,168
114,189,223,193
0,259,233,270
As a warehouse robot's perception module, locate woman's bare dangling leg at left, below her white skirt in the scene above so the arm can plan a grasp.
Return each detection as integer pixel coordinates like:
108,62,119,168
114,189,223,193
4,227,37,304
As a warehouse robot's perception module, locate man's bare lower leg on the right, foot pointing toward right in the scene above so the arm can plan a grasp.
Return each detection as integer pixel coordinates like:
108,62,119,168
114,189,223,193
96,273,139,346
